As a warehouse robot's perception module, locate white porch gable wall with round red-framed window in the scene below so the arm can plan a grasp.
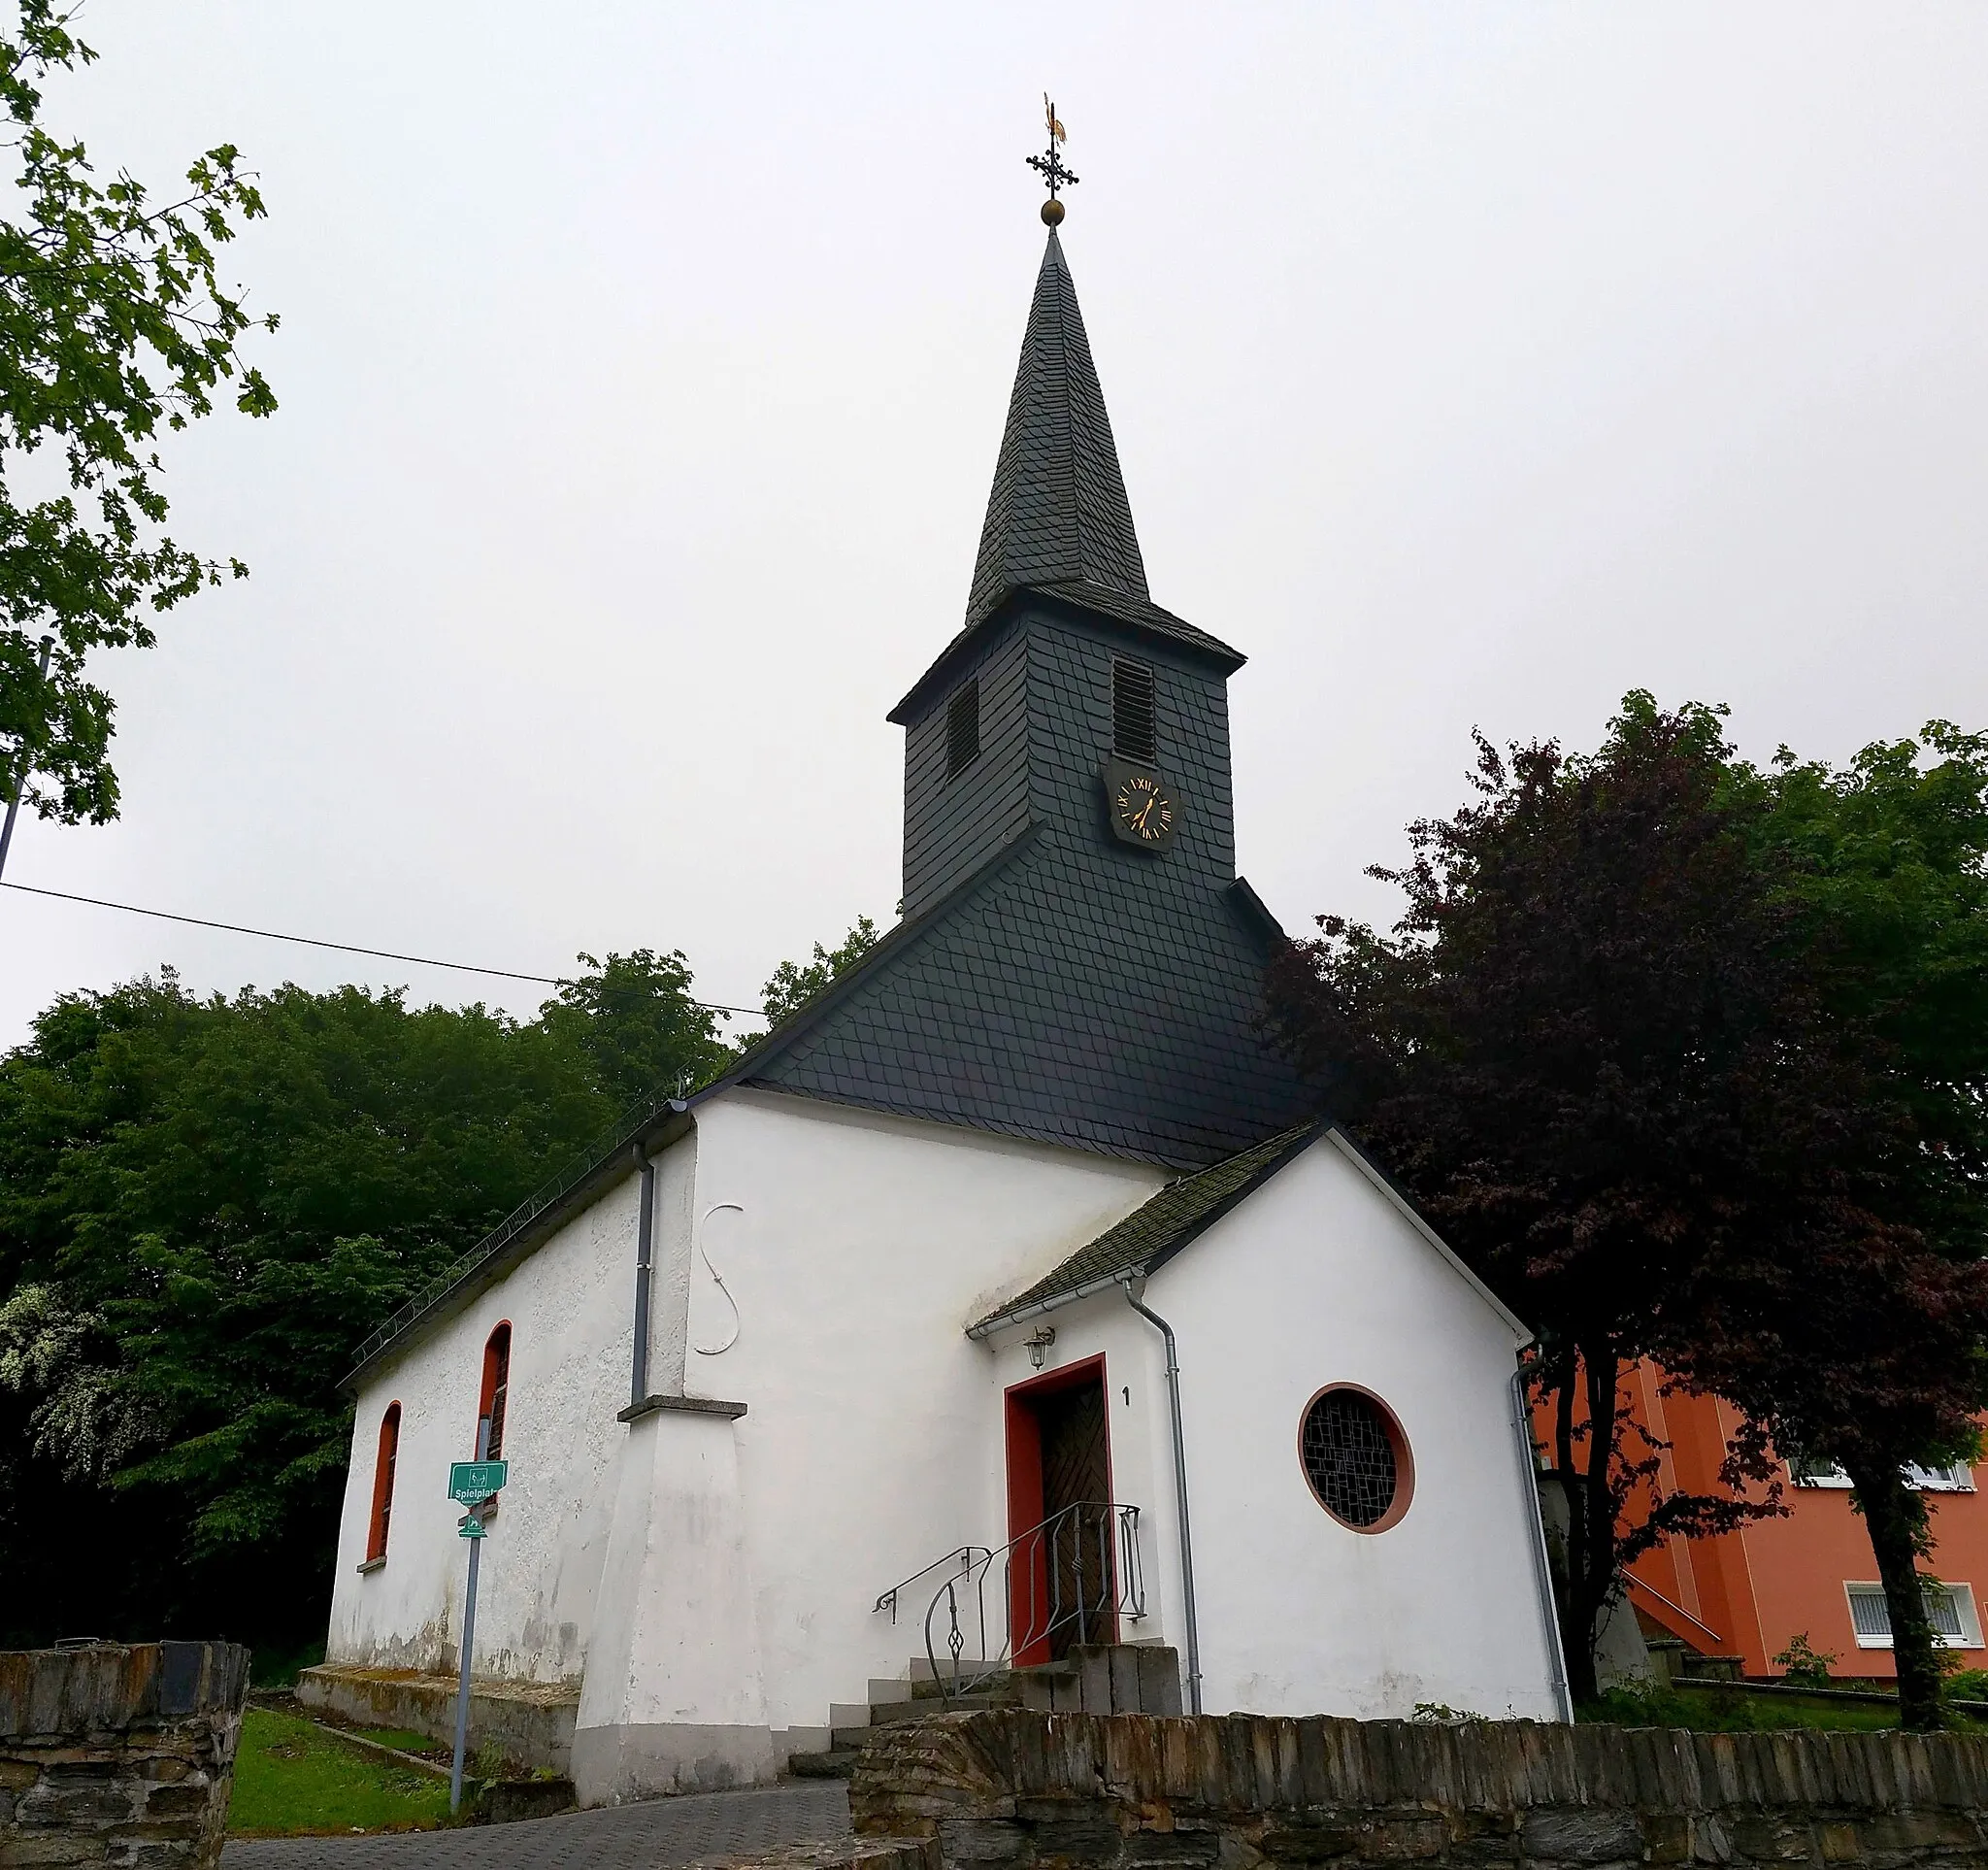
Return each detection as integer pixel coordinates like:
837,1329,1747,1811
1145,1138,1559,1719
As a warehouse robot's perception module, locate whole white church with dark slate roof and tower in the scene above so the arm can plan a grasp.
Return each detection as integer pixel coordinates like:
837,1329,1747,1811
328,201,1567,1804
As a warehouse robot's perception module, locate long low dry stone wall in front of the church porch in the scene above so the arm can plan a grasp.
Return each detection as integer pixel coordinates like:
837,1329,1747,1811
851,1709,1988,1870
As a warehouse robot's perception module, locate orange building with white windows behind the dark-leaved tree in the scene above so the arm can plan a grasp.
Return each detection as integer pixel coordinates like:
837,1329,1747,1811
1598,1365,1988,1677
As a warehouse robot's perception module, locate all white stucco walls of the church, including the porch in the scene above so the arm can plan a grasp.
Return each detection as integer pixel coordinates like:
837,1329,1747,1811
330,1090,1555,1758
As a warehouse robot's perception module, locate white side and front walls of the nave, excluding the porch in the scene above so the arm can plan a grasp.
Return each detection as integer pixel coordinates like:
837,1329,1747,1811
328,1092,1165,1743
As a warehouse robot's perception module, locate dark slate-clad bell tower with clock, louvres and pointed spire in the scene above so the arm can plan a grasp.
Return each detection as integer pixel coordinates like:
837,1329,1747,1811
891,231,1242,916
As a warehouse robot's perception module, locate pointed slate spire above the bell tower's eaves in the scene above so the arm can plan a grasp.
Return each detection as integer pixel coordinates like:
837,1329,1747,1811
966,227,1151,624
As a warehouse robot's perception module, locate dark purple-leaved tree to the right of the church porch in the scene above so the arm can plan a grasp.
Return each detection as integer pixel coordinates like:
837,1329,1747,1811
1267,694,1988,1722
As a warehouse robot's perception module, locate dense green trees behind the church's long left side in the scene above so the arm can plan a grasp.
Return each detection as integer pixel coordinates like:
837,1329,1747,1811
0,954,721,1641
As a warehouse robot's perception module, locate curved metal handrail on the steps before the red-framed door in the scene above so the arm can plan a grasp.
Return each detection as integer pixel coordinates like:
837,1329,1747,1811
910,1500,1145,1701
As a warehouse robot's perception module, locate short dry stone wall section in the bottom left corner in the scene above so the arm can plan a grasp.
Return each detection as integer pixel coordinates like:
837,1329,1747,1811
0,1643,248,1870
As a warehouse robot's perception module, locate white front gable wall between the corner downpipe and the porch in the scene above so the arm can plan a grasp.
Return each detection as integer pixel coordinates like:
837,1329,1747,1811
686,1092,1165,1729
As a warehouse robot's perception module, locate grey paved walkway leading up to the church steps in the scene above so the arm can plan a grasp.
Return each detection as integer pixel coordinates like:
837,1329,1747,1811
220,1781,848,1870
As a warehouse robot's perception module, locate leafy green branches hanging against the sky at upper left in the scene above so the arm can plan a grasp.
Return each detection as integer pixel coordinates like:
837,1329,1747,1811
0,0,277,823
